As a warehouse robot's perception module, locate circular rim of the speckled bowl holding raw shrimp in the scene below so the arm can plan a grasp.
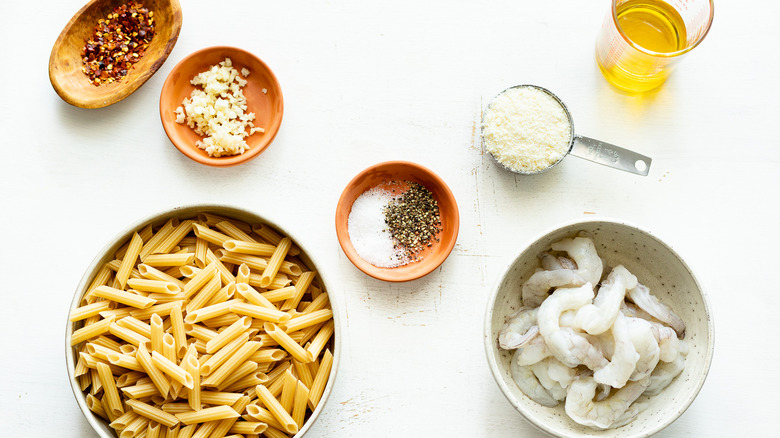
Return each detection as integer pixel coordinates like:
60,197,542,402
482,216,715,438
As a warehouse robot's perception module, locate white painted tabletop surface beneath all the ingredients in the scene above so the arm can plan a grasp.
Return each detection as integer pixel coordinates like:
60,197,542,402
0,0,780,438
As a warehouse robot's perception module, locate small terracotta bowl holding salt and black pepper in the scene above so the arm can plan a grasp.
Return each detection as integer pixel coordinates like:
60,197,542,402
336,161,460,282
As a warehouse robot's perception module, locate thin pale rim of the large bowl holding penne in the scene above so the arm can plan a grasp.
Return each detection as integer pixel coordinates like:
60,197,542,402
64,203,343,438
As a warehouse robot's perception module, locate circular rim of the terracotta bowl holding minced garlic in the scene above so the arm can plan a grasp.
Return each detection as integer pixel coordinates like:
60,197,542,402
159,46,284,167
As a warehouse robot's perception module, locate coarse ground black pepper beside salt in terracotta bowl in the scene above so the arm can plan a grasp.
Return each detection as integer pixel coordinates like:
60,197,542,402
384,181,441,260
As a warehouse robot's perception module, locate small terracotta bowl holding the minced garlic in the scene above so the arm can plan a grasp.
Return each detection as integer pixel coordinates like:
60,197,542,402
160,46,284,167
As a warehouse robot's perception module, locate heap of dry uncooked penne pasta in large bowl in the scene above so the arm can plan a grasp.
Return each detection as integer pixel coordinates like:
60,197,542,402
69,213,334,438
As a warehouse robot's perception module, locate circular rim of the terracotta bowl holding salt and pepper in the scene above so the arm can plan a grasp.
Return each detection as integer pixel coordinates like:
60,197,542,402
335,160,460,283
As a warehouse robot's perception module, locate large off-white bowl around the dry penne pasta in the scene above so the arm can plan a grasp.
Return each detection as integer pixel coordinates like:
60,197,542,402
65,204,341,438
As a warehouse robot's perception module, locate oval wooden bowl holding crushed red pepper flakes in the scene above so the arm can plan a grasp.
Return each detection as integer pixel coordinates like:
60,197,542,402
49,0,182,108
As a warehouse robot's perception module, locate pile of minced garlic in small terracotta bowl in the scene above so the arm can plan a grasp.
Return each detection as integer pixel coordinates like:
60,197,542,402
174,58,265,157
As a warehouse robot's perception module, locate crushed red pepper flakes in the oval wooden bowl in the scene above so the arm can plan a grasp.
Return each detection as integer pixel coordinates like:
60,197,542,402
81,2,154,86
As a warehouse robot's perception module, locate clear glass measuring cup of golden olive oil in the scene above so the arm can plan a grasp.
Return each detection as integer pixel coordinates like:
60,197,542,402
596,0,714,92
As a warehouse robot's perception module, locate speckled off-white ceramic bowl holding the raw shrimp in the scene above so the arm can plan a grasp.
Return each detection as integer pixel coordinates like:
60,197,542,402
484,219,714,438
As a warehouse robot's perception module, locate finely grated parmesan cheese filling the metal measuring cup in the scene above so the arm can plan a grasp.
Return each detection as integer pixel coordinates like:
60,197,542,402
482,87,571,173
